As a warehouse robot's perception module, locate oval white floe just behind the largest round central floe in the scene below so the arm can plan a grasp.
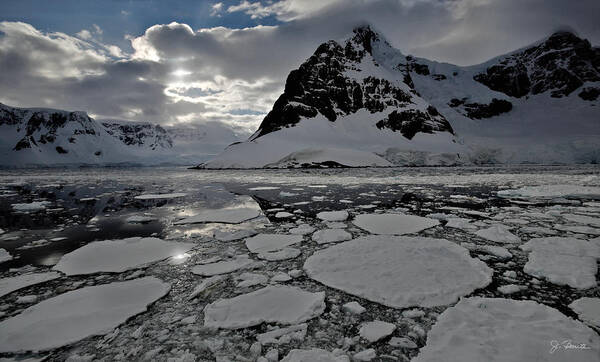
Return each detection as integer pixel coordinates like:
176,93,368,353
352,214,440,235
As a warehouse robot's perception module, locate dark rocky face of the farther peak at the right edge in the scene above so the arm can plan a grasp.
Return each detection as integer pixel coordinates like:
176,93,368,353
474,32,600,99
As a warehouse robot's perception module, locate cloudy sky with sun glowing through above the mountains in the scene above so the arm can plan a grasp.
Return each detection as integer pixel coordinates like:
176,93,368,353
0,0,600,132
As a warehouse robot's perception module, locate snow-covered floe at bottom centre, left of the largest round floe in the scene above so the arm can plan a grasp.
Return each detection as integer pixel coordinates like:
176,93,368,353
204,286,325,329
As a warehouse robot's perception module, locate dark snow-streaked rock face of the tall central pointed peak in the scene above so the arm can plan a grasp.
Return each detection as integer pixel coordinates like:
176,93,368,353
253,26,453,139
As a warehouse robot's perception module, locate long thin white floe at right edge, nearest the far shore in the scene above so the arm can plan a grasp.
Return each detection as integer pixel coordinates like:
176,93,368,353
498,185,600,199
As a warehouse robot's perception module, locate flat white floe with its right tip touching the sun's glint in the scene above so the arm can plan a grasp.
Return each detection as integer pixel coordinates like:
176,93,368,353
53,237,195,275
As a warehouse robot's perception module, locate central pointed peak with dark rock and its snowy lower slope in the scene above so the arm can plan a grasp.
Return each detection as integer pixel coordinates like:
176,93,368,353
203,26,462,168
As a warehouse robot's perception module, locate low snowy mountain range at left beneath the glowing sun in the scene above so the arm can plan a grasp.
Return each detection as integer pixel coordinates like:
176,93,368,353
0,104,244,167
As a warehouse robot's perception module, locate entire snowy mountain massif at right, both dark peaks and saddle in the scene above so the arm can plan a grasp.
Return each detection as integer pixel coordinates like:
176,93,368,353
201,26,600,168
